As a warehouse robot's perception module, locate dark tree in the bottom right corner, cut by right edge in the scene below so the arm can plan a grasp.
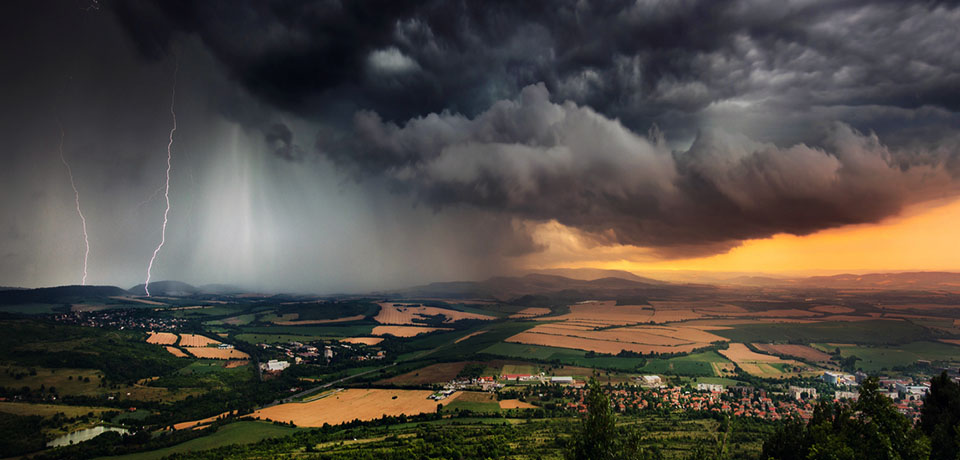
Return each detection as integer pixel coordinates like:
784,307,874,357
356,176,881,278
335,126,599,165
920,372,960,460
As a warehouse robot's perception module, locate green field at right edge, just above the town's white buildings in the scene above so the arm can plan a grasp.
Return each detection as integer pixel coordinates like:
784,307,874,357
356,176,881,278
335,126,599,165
816,342,960,372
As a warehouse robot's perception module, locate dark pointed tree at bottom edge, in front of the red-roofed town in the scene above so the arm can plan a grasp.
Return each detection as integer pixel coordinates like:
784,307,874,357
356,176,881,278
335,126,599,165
566,378,662,460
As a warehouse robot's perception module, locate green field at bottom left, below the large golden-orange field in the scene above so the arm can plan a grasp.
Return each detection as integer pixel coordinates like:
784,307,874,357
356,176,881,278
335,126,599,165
100,422,298,460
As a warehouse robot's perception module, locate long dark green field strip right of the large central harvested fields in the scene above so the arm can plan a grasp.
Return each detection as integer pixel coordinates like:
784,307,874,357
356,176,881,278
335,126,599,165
713,320,930,344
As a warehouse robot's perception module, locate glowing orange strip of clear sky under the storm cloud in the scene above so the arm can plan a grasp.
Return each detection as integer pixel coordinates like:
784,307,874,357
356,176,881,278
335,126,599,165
527,196,960,274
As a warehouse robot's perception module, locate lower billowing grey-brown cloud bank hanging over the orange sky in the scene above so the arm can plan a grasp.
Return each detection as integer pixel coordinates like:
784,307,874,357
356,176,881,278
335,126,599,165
327,85,957,256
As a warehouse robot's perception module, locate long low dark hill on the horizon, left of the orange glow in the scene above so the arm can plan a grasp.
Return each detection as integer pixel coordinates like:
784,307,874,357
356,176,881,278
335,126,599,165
385,274,715,303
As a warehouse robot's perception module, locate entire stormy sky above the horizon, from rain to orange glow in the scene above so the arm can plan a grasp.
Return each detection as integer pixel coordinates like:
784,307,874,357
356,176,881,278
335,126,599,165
0,0,960,292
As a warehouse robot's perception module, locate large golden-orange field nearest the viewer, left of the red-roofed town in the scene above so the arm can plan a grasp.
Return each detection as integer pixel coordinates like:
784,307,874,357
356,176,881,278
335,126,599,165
252,389,459,427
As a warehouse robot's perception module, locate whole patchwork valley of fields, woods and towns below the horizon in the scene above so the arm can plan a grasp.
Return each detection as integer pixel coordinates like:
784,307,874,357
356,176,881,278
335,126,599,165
0,272,960,459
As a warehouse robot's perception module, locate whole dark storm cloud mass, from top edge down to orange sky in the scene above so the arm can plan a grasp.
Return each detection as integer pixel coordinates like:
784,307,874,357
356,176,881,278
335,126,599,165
103,0,960,255
